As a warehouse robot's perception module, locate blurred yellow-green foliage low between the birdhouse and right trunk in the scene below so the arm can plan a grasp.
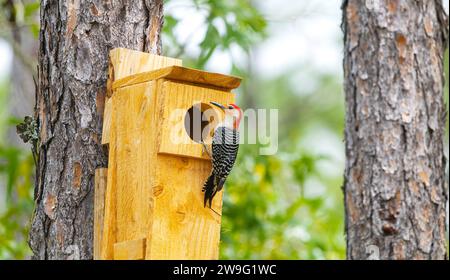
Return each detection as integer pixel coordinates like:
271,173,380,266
220,146,345,259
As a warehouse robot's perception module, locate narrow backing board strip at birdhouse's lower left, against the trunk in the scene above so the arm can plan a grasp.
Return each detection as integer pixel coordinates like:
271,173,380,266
94,168,108,260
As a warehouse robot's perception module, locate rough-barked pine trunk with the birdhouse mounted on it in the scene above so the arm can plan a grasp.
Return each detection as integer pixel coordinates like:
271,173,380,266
29,0,163,259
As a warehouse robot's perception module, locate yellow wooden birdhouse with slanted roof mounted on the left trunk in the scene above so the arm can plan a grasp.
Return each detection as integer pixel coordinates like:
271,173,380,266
94,49,240,259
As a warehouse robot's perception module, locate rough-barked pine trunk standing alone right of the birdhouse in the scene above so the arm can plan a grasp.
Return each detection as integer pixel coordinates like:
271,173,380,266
343,0,448,259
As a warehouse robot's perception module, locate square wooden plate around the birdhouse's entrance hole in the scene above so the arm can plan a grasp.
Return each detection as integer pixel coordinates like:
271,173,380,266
158,81,234,160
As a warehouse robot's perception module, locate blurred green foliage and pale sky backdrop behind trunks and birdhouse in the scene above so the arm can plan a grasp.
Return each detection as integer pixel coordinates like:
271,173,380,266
0,0,448,259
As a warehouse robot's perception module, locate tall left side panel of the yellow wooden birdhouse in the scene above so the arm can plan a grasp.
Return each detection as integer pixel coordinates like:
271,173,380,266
102,82,156,259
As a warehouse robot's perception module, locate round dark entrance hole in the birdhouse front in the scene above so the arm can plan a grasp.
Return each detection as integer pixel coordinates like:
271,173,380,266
184,103,217,143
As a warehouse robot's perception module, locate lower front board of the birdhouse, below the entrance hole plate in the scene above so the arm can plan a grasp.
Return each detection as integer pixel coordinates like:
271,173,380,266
146,155,223,260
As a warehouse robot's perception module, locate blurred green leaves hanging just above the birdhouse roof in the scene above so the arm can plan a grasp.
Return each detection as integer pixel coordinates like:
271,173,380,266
163,0,266,71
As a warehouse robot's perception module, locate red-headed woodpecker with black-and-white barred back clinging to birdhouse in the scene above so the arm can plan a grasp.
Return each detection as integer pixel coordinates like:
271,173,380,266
202,102,242,208
